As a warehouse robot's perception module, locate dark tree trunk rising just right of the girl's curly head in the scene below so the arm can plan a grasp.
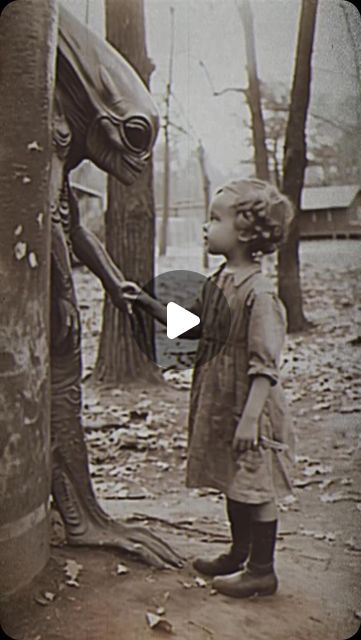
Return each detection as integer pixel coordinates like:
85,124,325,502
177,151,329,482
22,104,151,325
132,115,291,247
278,0,318,332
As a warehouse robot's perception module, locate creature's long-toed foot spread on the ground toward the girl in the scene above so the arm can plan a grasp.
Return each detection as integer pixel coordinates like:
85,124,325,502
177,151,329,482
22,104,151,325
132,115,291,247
67,516,183,569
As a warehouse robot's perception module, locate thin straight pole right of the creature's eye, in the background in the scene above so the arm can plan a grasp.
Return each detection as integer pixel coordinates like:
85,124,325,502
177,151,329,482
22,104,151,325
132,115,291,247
159,7,174,256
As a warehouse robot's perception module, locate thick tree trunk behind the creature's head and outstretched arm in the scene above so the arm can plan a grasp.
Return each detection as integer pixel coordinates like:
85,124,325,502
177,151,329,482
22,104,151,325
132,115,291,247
96,0,160,384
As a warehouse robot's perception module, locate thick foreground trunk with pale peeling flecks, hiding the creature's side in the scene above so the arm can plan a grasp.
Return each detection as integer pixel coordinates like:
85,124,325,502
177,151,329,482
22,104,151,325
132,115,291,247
0,0,57,594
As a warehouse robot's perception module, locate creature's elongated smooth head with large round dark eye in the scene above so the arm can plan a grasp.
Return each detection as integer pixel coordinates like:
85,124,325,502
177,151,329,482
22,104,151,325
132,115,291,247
57,5,159,184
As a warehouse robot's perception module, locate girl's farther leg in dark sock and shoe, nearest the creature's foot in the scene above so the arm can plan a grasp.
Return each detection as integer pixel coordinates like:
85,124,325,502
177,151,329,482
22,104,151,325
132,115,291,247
193,497,252,576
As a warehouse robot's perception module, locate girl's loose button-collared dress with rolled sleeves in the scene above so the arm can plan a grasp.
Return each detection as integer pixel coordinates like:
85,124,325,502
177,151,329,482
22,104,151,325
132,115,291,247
186,263,294,504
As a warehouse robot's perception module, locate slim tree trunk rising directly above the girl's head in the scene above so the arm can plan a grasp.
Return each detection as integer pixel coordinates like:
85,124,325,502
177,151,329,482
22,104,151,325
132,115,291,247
239,0,270,180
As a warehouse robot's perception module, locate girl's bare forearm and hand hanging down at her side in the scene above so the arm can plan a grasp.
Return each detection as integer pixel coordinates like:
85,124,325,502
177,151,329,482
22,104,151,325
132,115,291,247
232,375,271,453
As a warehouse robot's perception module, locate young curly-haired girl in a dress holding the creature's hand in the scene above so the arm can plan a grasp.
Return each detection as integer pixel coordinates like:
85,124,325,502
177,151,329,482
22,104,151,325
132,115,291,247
124,179,294,598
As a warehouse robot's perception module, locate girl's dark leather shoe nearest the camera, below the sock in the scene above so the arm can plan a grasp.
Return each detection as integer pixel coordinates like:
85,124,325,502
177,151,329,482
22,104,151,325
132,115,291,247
212,568,278,598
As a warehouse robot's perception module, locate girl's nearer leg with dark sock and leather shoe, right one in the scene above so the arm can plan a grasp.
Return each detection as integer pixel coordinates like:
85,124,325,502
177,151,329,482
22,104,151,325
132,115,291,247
213,501,278,598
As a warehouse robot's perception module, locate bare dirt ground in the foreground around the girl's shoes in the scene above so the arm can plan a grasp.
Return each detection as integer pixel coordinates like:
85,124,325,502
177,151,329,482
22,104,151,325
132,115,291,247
2,388,361,640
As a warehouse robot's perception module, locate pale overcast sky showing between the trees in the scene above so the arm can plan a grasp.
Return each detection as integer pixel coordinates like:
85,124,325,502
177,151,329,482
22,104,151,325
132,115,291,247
62,0,361,181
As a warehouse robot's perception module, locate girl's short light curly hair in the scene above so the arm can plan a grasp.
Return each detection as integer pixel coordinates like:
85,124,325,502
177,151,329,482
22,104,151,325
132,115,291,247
217,178,294,254
